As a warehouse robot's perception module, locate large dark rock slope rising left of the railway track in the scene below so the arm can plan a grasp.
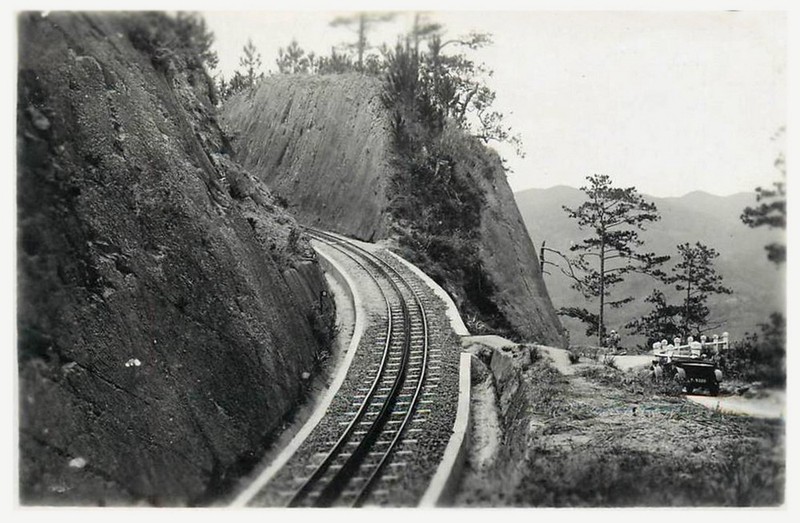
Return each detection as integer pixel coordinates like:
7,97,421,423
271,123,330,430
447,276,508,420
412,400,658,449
17,13,327,505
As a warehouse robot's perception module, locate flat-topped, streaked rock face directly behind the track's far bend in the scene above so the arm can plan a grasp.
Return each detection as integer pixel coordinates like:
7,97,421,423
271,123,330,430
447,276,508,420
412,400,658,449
224,74,390,241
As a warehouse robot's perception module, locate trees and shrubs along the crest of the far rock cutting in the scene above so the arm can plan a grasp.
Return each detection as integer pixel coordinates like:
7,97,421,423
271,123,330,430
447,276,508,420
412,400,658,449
222,12,524,157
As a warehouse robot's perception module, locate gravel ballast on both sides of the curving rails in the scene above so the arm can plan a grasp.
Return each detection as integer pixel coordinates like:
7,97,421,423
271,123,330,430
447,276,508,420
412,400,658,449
250,235,460,506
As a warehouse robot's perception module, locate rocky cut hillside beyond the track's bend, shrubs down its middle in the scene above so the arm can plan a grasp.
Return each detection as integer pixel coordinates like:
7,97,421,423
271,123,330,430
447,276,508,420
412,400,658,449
223,75,562,344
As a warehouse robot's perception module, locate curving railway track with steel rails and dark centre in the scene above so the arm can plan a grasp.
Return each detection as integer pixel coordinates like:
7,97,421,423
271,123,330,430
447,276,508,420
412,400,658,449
287,230,429,507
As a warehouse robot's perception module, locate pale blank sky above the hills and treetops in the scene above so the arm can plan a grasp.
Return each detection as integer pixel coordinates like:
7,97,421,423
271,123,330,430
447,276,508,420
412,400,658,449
205,11,787,196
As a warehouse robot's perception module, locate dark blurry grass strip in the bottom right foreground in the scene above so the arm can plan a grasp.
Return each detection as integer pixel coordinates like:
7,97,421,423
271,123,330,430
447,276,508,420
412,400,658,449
512,434,783,507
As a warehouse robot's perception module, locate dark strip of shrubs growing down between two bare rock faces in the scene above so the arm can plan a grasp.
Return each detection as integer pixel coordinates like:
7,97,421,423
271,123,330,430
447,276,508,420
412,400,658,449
383,40,514,336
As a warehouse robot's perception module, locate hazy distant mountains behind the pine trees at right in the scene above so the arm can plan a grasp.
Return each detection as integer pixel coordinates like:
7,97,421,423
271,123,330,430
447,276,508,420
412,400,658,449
514,186,785,346
